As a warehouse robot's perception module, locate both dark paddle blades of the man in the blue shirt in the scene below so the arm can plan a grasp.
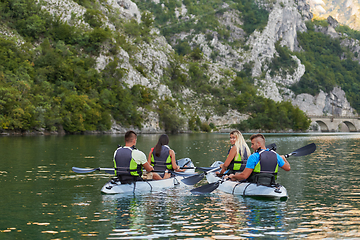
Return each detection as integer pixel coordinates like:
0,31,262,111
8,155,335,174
190,143,316,194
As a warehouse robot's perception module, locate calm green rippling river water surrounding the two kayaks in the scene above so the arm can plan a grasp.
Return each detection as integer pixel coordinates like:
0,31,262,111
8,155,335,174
0,133,360,239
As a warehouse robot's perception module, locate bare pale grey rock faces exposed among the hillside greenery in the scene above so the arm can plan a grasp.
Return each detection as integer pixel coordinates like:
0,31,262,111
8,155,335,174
16,0,360,133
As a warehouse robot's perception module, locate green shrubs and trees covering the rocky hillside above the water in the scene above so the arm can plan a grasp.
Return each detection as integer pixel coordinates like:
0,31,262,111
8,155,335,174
4,0,358,133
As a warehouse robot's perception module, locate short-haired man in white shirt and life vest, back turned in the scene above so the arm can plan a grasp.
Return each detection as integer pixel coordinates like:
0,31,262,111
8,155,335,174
114,130,154,183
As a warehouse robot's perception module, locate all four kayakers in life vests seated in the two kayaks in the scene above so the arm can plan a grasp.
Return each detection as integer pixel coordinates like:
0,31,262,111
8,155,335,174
114,130,290,185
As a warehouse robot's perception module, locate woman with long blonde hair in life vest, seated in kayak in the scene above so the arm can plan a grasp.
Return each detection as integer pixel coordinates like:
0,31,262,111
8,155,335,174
217,130,251,175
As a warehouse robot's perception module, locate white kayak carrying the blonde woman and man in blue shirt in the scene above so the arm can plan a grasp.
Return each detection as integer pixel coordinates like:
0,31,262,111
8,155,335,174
206,161,288,200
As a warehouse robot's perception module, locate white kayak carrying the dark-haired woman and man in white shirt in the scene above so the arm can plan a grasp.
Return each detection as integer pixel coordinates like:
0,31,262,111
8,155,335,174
101,158,195,194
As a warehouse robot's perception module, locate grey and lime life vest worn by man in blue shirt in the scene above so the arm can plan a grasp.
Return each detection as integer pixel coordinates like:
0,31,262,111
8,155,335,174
247,149,279,186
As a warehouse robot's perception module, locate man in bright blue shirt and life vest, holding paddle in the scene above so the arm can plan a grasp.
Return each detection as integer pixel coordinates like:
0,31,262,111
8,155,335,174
229,133,290,185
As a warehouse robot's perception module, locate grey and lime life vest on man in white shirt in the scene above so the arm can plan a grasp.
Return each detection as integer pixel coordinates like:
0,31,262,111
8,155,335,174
114,147,142,177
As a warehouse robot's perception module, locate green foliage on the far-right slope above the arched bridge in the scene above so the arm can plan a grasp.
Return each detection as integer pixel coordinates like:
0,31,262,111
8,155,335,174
292,22,360,112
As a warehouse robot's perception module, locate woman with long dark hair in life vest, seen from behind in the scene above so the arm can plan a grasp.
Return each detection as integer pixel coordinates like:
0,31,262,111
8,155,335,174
148,134,182,180
